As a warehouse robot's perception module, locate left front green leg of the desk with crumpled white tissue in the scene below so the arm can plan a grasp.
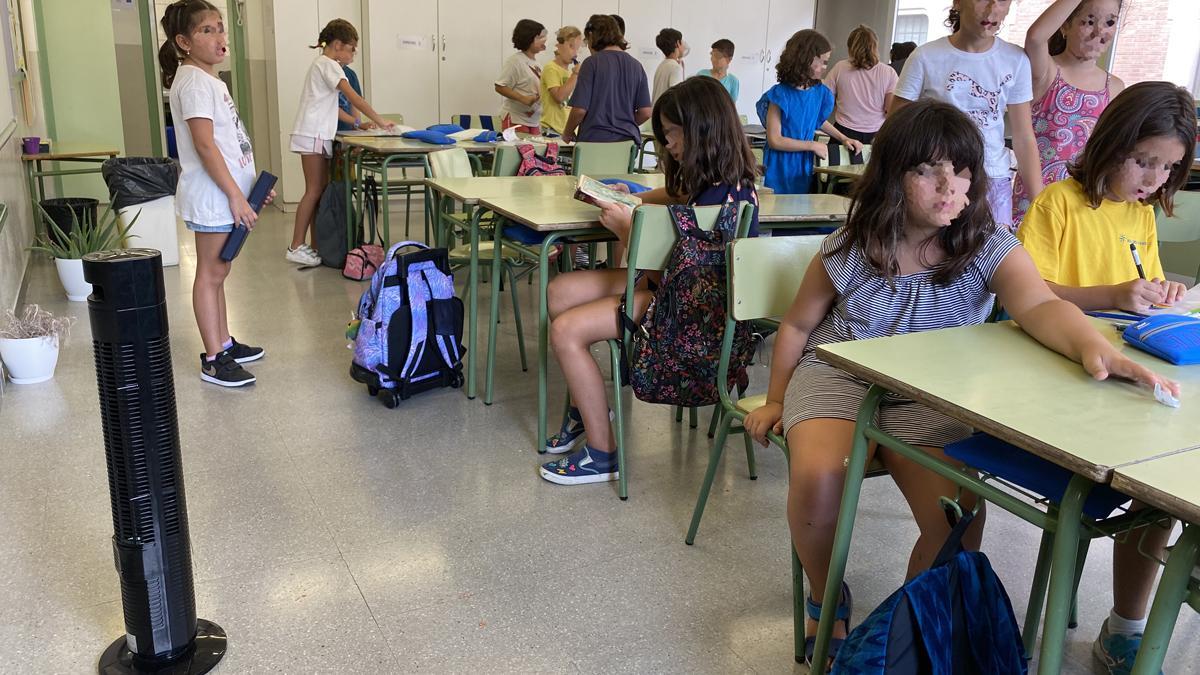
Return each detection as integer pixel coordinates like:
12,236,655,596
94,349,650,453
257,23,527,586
793,384,892,673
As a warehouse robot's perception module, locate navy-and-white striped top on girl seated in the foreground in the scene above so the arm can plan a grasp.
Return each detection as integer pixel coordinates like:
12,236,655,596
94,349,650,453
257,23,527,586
804,227,1020,356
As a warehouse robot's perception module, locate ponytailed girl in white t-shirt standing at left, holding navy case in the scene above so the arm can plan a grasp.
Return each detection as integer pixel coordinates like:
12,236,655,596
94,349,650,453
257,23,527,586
158,0,275,387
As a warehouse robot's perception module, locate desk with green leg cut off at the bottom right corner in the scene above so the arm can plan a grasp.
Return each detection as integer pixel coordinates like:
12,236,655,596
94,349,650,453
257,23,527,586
1112,449,1200,675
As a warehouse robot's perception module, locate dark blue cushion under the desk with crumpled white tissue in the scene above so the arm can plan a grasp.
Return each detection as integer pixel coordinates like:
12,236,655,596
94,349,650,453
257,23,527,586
946,434,1130,519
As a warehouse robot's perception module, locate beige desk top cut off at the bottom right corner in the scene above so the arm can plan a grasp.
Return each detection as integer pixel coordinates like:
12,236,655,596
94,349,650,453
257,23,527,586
1112,448,1200,526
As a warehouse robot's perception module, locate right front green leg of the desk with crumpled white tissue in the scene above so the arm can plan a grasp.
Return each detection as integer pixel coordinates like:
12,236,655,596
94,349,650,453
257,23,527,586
1038,476,1094,675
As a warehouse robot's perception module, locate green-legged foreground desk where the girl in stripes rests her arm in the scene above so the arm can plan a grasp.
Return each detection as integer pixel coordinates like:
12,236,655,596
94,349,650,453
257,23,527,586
815,319,1200,674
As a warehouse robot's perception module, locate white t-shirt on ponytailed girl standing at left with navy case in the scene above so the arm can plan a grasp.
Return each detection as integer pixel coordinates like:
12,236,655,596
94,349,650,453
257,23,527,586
170,66,256,226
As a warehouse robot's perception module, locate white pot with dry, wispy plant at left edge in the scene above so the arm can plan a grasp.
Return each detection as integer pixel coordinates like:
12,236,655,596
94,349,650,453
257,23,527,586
0,305,74,384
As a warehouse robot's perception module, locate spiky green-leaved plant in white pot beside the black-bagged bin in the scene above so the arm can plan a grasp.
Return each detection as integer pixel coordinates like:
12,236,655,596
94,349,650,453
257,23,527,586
29,204,140,301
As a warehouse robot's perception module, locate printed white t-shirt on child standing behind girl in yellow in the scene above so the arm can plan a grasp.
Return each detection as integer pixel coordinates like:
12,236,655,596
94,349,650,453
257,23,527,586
895,37,1033,178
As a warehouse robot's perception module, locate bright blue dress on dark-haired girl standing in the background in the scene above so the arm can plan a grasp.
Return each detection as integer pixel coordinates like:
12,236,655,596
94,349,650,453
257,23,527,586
755,83,833,195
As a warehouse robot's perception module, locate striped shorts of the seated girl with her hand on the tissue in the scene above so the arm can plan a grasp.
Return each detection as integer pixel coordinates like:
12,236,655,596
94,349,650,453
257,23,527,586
782,353,972,448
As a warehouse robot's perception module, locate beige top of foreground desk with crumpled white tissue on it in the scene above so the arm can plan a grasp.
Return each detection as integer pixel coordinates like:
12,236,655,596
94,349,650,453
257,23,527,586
817,319,1200,483
